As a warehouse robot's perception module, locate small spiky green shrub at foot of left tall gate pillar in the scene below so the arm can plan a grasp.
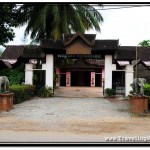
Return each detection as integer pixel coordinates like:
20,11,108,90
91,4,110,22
38,87,53,97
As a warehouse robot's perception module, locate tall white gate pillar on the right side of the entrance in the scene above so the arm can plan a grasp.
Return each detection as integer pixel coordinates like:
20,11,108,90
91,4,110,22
104,55,116,89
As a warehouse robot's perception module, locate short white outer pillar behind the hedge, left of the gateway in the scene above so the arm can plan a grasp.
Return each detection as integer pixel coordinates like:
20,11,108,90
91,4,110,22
25,64,33,85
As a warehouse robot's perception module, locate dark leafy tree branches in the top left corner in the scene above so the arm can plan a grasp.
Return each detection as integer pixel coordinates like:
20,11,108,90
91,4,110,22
0,4,21,45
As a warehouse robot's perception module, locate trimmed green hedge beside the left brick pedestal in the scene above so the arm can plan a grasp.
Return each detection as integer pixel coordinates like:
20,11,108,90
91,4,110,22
9,85,36,104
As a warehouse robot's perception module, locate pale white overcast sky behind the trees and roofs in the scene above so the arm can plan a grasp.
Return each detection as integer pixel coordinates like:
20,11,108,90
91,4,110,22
6,6,150,46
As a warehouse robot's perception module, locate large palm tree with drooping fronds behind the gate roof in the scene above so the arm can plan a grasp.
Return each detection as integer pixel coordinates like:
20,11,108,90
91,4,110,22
19,3,103,42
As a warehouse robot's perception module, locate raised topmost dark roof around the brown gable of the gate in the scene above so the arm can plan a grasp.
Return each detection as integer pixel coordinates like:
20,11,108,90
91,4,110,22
64,32,96,46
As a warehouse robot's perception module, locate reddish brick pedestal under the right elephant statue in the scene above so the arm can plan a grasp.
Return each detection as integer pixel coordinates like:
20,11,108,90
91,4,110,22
129,95,149,114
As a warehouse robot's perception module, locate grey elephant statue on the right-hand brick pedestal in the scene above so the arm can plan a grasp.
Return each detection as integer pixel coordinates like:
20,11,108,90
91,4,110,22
133,78,146,96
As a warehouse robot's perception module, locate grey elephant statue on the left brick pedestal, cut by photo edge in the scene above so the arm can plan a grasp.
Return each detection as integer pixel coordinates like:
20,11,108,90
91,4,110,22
0,76,9,93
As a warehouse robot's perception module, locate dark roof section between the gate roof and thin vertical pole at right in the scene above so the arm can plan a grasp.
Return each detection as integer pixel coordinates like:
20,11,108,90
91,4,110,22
116,46,136,60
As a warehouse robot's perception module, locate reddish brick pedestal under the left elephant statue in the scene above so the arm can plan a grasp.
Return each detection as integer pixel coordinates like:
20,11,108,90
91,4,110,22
0,93,14,112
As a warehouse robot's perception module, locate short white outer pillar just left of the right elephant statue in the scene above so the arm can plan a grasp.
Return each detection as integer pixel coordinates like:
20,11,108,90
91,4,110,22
125,65,134,96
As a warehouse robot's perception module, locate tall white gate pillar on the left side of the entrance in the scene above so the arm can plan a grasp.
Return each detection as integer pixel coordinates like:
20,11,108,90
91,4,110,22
42,54,54,89
